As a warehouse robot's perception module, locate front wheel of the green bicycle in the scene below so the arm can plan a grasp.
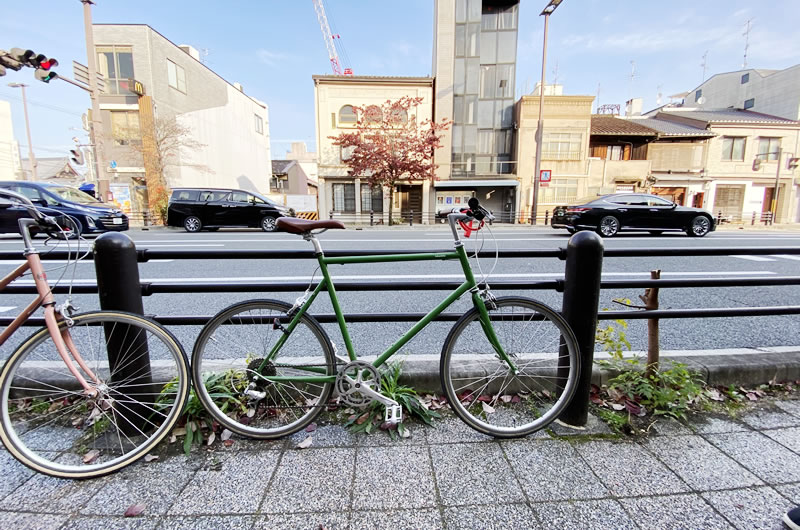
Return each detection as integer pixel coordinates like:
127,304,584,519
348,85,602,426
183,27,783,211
440,297,579,438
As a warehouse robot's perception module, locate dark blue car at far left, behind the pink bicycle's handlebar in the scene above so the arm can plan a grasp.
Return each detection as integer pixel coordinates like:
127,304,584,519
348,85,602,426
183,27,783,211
0,180,128,234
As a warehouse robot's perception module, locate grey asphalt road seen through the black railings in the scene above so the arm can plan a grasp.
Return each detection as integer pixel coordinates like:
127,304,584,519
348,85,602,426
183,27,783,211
0,225,800,357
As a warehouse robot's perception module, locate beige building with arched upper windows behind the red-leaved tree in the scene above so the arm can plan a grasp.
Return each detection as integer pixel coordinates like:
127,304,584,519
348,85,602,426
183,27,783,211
312,75,433,223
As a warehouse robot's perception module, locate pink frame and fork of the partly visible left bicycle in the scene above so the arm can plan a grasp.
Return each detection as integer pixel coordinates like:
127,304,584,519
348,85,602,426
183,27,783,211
0,223,100,395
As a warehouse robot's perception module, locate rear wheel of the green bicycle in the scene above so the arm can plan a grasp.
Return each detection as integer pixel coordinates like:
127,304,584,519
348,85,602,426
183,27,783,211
192,300,336,439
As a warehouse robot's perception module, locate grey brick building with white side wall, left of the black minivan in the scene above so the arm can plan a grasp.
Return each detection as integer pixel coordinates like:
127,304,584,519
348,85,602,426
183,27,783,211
93,24,271,218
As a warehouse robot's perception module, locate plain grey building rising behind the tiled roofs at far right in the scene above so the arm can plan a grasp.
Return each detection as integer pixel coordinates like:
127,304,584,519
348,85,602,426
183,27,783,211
686,64,800,120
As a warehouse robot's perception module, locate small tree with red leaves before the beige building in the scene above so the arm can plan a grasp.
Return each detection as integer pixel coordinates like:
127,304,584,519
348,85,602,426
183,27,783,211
330,96,451,224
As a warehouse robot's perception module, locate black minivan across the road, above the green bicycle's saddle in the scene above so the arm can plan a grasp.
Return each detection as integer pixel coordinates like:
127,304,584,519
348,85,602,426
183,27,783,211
167,188,289,232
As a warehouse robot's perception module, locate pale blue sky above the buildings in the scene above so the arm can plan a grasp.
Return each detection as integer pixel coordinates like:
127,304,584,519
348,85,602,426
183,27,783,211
0,0,800,159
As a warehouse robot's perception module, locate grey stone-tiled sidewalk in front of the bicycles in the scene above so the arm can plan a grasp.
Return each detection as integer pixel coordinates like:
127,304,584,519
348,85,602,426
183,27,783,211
0,394,800,530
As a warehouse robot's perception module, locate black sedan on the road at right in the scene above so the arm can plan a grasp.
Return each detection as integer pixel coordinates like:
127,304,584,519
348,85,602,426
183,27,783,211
551,193,716,237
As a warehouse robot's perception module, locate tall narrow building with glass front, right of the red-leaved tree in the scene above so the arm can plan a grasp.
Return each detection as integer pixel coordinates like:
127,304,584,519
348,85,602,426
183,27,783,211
431,0,519,221
